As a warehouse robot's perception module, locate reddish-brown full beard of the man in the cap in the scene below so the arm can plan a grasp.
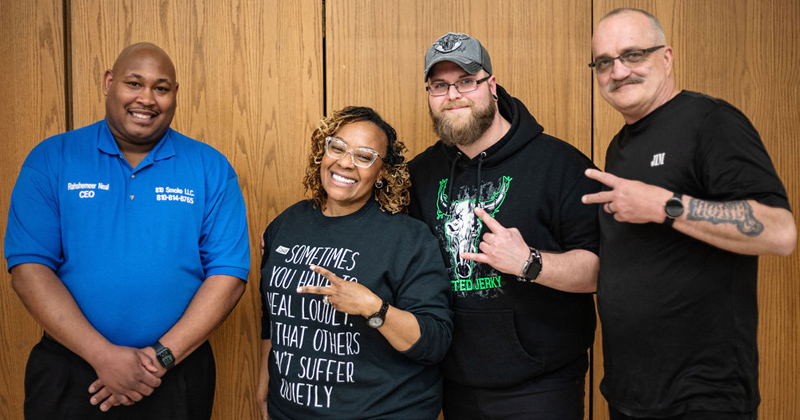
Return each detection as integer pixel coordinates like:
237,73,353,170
428,95,497,146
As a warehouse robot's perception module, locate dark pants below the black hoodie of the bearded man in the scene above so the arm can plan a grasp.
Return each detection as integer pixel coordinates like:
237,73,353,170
443,376,586,420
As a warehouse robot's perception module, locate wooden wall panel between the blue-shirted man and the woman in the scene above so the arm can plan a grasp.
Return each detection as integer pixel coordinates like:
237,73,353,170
66,0,323,419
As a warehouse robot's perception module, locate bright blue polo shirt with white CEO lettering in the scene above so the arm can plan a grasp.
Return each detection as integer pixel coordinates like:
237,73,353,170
5,120,250,347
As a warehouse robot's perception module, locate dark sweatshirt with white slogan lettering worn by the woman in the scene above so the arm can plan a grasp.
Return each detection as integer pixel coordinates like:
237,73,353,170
261,200,453,420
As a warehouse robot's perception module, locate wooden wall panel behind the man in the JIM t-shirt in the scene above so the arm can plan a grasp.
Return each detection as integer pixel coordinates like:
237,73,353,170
593,0,800,420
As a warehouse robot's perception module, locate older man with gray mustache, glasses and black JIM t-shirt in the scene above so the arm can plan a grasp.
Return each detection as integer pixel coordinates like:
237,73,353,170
584,9,797,420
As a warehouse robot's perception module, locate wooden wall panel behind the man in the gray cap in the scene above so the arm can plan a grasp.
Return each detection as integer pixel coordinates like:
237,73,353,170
326,0,591,156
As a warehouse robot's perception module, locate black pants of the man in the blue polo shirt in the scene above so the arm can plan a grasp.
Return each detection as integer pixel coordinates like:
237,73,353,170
25,337,216,420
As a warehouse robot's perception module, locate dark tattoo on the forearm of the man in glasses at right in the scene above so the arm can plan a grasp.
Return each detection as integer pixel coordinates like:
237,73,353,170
686,198,764,236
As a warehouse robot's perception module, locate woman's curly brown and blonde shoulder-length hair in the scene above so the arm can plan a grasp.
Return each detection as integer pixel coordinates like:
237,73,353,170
303,106,411,214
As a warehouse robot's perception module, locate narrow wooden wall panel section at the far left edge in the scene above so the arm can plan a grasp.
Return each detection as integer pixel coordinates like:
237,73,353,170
0,0,66,419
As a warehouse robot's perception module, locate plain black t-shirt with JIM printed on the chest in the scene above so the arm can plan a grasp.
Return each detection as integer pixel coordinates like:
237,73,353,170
597,91,789,417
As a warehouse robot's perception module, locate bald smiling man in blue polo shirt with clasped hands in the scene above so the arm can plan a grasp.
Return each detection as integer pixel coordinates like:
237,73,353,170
5,43,250,419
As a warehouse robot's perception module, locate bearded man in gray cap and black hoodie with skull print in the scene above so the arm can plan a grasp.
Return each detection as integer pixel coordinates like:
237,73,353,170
409,33,600,420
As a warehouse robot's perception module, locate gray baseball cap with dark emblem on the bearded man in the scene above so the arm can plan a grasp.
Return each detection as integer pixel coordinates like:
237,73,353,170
424,32,492,82
